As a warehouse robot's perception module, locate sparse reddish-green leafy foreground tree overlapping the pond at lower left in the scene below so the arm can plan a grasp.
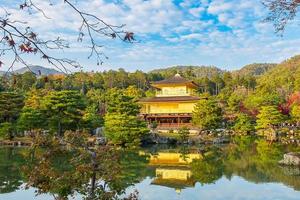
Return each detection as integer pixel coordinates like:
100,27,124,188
23,132,137,200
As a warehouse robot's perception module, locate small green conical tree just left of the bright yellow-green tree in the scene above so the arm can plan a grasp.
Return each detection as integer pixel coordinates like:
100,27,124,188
233,113,255,134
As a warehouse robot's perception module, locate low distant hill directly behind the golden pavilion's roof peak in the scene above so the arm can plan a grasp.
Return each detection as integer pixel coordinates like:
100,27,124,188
149,66,225,78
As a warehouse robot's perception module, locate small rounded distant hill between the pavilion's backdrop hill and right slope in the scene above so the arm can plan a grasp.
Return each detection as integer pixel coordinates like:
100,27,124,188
232,63,277,76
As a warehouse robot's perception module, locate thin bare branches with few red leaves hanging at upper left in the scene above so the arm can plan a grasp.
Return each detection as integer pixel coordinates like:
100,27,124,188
0,0,135,75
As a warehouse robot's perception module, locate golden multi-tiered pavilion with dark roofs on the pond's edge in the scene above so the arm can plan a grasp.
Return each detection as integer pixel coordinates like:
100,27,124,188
140,74,200,127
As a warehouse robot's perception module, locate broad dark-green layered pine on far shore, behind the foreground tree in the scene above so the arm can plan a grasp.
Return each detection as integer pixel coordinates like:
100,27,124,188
42,90,85,136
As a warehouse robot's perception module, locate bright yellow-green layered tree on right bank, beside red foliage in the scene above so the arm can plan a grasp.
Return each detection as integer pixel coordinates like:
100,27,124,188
255,106,284,129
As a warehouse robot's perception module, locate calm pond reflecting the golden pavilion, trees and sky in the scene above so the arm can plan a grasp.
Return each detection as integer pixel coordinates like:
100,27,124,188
0,137,300,200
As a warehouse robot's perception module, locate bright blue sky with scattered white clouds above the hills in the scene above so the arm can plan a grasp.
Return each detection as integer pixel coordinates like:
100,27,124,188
0,0,300,71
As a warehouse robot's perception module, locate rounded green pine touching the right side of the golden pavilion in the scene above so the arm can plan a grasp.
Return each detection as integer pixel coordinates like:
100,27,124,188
192,99,222,130
